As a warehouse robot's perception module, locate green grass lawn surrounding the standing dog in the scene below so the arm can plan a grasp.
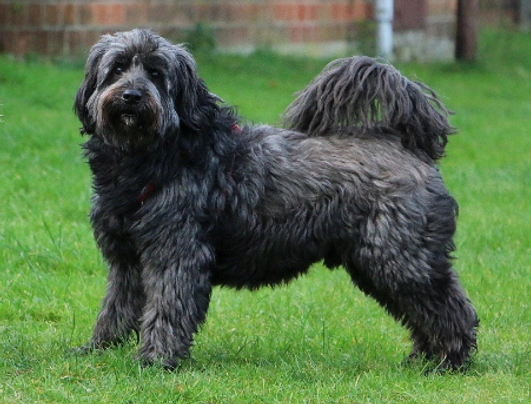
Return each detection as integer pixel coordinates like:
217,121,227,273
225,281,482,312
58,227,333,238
0,32,531,404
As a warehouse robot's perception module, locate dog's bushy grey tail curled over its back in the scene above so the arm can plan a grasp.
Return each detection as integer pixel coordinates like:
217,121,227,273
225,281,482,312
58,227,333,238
283,56,455,161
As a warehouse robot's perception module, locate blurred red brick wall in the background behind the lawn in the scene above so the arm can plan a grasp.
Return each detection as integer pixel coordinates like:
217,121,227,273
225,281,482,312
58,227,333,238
0,0,456,60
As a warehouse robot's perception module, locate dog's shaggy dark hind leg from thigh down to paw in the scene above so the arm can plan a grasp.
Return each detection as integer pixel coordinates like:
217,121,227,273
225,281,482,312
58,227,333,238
344,199,478,369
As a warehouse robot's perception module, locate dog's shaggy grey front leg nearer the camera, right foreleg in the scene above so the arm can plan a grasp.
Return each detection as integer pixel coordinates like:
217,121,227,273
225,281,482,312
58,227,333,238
138,235,214,369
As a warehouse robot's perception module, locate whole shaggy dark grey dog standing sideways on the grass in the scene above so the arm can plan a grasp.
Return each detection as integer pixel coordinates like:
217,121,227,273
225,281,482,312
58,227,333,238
75,30,478,369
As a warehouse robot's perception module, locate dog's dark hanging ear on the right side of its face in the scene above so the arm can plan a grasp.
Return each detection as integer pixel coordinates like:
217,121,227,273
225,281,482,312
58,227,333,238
172,45,222,131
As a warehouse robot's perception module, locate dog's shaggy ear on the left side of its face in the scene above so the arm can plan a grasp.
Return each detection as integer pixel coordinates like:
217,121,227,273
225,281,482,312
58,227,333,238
74,36,108,134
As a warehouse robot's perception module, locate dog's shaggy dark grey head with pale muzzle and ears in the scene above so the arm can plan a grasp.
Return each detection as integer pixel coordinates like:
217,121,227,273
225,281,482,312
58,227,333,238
74,30,219,148
